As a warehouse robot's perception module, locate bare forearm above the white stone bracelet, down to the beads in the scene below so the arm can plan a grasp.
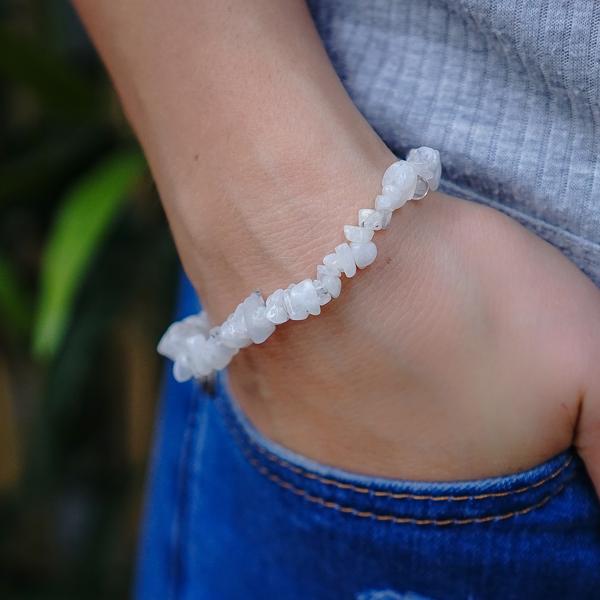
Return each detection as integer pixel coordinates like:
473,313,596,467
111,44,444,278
76,0,392,320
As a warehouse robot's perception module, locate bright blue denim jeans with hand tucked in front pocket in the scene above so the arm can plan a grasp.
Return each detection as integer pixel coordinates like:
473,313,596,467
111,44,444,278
137,282,600,600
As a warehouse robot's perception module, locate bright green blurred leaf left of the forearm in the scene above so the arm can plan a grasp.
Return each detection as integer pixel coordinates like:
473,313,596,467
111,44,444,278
33,152,145,358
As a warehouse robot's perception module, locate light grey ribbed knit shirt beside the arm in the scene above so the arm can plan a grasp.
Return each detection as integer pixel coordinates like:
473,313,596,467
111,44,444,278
309,0,600,285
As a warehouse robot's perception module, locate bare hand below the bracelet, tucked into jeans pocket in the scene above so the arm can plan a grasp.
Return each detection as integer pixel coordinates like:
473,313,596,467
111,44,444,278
230,188,600,486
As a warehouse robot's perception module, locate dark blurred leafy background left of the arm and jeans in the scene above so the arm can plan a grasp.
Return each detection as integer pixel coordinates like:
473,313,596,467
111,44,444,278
0,0,178,599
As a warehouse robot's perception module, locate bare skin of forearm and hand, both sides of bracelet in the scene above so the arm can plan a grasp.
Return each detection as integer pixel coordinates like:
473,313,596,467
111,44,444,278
75,0,600,489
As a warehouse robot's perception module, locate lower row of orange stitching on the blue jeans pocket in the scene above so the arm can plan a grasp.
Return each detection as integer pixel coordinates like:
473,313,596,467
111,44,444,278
240,436,566,526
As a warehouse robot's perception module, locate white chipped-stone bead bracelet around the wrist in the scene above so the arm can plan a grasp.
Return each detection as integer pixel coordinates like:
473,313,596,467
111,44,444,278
158,146,441,382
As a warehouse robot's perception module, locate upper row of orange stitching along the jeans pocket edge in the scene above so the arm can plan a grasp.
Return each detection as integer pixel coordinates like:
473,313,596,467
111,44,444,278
241,422,573,502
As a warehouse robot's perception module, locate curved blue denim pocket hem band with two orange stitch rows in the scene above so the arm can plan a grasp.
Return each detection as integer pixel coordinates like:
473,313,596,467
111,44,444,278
217,372,581,526
